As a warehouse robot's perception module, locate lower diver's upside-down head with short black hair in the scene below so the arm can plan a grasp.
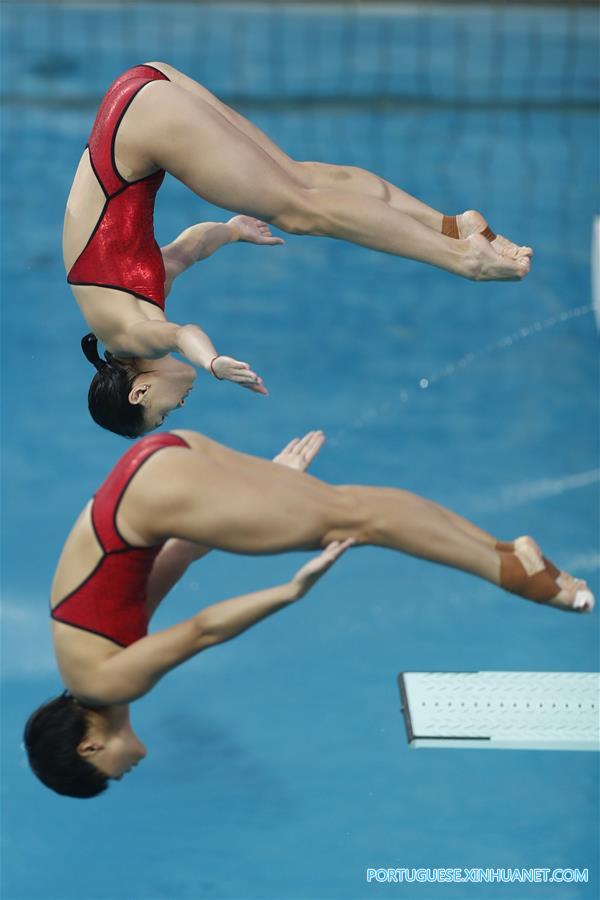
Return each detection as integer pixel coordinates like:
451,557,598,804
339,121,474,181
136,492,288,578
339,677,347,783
24,691,146,798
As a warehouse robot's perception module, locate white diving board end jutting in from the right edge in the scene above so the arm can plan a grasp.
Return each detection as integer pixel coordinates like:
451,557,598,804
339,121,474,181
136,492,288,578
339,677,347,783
398,672,600,750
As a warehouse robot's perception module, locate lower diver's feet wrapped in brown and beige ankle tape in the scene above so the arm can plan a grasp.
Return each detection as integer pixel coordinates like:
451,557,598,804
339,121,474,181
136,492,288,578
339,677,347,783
498,537,595,613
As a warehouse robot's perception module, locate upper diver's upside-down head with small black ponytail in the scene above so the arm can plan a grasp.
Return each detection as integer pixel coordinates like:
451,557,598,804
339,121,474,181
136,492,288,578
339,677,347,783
81,334,196,438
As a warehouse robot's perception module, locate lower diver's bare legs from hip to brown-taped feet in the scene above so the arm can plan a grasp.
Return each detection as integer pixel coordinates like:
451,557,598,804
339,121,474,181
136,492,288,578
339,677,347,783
128,450,584,609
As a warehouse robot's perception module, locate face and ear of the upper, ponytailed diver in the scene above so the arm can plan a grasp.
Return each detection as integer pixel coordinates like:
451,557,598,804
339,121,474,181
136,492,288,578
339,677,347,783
130,356,196,432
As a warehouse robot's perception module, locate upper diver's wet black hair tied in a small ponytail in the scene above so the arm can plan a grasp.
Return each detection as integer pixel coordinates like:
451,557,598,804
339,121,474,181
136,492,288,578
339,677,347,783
81,332,145,438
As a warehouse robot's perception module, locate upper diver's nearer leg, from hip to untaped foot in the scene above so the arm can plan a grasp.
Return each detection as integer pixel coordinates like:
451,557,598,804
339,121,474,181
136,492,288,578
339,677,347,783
117,81,529,280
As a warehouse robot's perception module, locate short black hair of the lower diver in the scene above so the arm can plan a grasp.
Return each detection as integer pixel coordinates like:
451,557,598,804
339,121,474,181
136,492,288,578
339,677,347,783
23,691,108,798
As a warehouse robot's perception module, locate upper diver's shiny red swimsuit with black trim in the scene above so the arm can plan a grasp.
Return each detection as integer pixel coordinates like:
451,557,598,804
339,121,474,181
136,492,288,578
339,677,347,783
67,66,169,309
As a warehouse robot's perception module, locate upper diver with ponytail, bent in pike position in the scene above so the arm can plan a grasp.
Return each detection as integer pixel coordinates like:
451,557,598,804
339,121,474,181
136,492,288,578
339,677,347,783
63,63,532,437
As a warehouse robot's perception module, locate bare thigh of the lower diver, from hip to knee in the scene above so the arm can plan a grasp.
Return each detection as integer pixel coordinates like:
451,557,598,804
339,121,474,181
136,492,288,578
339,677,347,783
123,449,355,554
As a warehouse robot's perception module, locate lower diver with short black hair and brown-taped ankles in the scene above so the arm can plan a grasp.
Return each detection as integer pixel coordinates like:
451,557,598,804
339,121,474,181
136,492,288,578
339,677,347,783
25,431,594,796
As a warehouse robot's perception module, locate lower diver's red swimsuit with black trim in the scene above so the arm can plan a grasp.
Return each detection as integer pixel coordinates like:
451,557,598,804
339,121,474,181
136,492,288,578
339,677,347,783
50,433,189,647
